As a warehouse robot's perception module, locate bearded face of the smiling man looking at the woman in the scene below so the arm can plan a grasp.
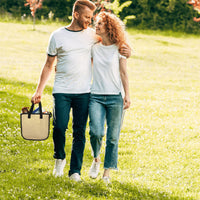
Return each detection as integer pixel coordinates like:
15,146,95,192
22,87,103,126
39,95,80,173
77,7,93,29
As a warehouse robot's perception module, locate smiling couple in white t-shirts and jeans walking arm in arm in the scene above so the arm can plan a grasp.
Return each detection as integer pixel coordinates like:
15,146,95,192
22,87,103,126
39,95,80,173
31,0,131,182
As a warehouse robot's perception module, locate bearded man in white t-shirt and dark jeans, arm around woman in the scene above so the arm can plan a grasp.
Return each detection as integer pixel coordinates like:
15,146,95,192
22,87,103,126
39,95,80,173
31,0,130,181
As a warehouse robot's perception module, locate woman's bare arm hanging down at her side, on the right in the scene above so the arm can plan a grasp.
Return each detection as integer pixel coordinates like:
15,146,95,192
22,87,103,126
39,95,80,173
119,58,131,109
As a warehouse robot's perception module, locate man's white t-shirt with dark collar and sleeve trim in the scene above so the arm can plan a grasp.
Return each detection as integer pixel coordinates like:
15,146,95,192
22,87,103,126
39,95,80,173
47,27,96,94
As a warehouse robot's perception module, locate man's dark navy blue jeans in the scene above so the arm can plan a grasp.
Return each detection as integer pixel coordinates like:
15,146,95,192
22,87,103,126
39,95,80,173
53,93,90,176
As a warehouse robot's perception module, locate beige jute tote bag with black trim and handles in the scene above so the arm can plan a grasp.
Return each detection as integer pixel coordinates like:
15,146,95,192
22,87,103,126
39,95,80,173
20,102,51,140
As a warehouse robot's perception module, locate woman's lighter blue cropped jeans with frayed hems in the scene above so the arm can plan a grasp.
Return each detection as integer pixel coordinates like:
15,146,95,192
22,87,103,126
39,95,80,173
89,94,123,169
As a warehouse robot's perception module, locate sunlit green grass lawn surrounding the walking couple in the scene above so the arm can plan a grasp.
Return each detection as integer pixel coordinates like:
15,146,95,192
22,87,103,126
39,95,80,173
0,23,200,200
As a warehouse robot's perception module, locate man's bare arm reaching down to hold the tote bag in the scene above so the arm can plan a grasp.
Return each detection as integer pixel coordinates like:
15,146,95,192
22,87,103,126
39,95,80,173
31,55,56,104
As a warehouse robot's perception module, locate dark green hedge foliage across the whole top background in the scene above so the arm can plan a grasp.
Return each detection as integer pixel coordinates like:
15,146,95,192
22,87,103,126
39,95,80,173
0,0,200,34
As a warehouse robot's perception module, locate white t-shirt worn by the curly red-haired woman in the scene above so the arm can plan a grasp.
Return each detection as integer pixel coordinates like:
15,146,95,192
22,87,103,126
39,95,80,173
91,43,124,96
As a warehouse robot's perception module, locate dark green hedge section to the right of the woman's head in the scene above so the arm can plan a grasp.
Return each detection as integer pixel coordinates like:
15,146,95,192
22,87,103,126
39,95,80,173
121,0,200,33
